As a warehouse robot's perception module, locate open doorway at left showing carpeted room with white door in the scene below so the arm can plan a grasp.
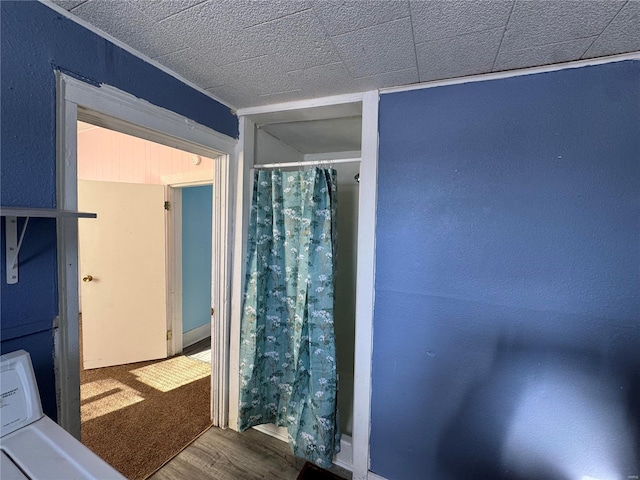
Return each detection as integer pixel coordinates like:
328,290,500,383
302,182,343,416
77,122,215,478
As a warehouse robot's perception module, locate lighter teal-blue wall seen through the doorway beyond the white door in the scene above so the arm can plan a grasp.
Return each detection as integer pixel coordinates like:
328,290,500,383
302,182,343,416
182,185,213,333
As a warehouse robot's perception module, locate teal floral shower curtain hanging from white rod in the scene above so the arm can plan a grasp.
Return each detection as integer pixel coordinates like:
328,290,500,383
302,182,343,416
238,168,340,467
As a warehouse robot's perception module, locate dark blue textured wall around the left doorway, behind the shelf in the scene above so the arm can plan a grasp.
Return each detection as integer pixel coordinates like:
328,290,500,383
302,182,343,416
0,1,238,418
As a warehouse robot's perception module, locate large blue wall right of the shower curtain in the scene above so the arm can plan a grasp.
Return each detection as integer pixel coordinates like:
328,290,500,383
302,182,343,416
371,61,640,480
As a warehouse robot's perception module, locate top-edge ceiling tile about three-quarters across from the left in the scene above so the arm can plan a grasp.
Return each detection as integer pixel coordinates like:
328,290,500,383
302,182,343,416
411,0,513,43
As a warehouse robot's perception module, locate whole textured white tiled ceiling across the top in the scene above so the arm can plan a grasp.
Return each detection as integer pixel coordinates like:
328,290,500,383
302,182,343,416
47,0,640,108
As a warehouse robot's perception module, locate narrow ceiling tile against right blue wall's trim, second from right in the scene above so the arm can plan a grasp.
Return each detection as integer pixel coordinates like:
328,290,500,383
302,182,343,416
493,37,596,72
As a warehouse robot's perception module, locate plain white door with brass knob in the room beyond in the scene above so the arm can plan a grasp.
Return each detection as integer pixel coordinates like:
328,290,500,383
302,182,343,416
78,180,167,369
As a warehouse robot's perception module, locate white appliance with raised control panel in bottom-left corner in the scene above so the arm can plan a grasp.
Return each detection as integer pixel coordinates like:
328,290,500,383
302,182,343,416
0,350,125,480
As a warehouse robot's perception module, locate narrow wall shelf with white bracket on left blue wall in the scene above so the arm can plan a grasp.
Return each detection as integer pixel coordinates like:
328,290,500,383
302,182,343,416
0,207,97,285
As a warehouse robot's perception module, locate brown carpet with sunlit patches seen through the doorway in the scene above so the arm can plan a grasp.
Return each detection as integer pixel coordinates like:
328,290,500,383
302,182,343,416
80,356,211,480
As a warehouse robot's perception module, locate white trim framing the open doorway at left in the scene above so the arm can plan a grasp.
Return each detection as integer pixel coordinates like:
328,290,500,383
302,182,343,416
54,72,237,438
